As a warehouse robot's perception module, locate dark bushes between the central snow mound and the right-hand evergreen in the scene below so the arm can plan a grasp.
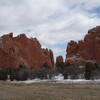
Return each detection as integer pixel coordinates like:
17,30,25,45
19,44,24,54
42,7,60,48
56,62,84,79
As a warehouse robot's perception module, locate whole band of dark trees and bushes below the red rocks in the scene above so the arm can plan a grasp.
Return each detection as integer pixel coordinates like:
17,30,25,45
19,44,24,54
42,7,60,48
0,62,100,81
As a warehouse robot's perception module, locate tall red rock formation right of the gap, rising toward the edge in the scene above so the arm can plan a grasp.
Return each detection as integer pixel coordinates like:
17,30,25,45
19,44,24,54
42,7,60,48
66,26,100,65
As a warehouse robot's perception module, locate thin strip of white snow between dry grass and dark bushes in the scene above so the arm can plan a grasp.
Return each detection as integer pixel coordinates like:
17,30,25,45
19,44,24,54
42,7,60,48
11,74,100,84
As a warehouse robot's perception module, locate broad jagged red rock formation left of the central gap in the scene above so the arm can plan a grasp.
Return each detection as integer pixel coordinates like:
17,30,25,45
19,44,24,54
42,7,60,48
0,33,54,68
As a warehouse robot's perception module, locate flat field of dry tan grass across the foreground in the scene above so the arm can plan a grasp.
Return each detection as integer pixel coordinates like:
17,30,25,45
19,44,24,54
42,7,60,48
0,81,100,100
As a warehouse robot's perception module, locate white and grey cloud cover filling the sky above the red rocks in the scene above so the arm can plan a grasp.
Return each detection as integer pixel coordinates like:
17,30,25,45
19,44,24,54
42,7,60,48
0,0,100,59
